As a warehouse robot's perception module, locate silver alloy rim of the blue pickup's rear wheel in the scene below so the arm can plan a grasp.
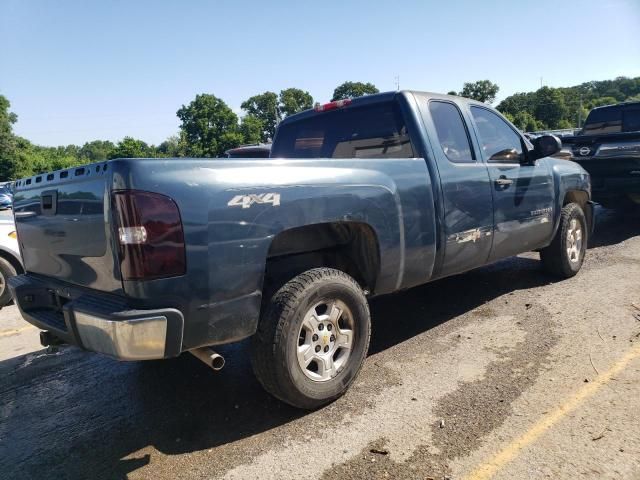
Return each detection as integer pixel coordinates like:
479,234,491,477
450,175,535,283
297,299,354,382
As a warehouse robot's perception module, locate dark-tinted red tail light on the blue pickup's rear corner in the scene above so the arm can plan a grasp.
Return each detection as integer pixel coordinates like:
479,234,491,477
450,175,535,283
112,190,186,280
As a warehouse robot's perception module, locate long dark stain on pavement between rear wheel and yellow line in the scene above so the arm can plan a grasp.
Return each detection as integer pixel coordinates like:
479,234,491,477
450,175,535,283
323,303,559,480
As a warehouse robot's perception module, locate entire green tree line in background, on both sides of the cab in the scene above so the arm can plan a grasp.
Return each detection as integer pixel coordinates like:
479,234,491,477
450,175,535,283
0,77,640,180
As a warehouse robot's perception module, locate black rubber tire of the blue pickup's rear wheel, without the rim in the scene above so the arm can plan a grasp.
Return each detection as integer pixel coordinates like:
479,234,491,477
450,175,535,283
251,268,371,410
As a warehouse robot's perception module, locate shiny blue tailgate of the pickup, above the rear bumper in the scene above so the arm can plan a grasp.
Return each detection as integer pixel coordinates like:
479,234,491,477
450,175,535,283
14,163,122,292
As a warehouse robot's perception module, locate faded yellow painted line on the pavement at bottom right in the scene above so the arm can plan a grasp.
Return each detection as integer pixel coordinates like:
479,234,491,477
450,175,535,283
465,343,640,480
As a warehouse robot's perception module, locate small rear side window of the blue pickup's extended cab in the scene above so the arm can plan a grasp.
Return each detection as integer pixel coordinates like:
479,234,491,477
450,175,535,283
429,101,475,163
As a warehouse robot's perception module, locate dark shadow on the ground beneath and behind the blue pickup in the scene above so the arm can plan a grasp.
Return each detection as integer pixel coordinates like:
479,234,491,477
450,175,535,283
0,256,553,478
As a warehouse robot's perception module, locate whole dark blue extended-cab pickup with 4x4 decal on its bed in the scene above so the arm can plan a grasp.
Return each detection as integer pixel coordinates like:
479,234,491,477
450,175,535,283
9,91,594,409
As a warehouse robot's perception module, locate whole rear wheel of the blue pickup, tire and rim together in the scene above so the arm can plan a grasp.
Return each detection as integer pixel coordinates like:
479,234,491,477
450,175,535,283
251,268,371,409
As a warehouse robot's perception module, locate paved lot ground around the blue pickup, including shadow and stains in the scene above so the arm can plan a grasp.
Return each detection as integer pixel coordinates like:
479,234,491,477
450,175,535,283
0,207,640,479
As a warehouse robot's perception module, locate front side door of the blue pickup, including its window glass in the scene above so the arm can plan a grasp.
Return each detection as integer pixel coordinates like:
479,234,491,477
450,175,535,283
470,105,554,261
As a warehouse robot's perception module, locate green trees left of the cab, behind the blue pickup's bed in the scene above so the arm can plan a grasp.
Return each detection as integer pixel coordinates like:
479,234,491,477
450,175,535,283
0,82,379,181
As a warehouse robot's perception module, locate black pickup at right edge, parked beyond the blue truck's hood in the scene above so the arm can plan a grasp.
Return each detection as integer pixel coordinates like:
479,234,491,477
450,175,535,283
558,102,640,207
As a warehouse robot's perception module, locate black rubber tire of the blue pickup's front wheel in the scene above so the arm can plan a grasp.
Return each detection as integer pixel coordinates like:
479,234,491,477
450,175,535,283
540,203,589,278
